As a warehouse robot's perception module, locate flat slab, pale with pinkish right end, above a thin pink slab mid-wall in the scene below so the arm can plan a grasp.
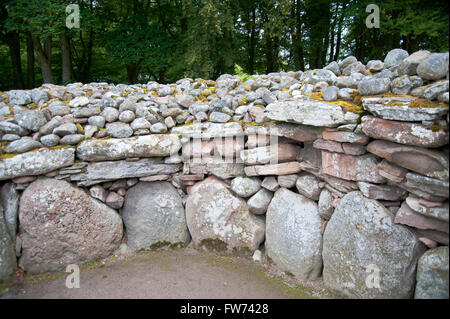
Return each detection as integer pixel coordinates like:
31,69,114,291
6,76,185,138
240,144,300,165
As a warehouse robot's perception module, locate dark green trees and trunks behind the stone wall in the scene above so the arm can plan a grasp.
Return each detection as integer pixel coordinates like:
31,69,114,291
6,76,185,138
0,0,449,90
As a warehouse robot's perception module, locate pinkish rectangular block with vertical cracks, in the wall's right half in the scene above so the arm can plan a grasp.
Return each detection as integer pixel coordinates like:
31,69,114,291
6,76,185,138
322,151,385,183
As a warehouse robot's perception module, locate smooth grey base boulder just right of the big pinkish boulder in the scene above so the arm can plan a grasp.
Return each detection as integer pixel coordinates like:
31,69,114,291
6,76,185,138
122,182,190,249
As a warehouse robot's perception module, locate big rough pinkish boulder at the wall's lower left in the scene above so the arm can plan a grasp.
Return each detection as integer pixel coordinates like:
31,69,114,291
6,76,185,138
19,178,123,273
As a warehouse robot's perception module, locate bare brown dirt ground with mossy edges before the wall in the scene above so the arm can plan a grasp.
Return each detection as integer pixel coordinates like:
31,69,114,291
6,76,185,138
0,248,334,299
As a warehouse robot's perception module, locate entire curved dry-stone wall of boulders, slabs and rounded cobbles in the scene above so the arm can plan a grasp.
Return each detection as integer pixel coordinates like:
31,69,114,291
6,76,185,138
0,49,449,298
